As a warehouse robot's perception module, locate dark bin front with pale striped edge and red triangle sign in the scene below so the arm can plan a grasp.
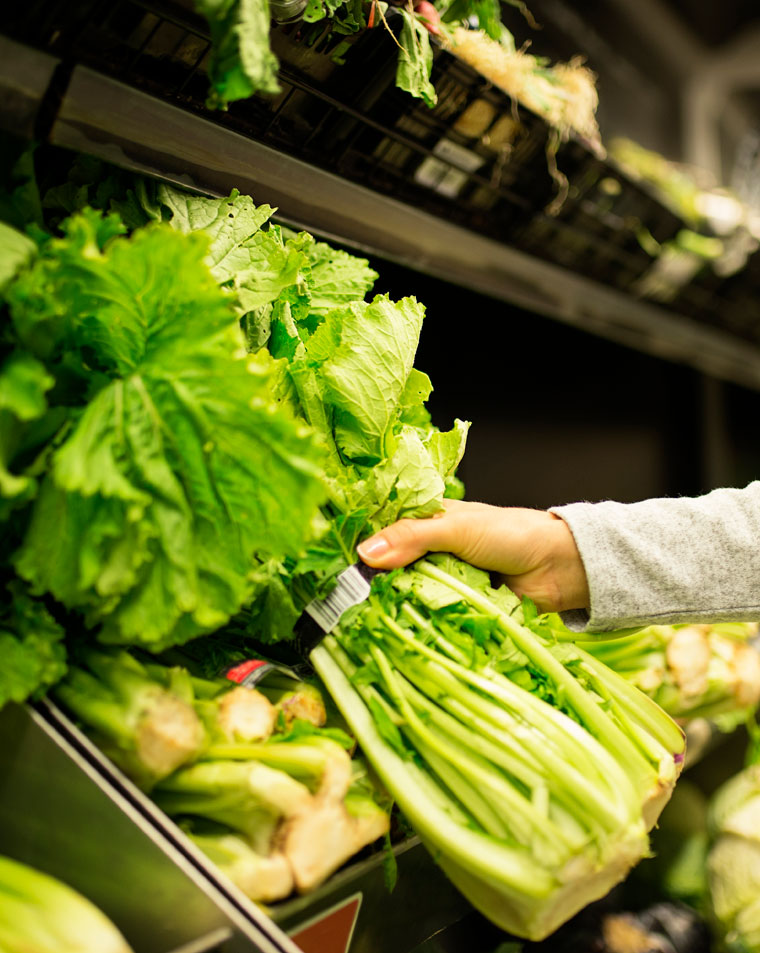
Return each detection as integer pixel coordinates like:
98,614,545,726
11,701,472,953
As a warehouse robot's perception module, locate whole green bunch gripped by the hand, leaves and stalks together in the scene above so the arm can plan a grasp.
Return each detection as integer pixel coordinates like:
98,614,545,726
99,177,683,938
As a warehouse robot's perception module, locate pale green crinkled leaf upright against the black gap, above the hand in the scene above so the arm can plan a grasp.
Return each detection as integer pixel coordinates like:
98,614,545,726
308,295,424,464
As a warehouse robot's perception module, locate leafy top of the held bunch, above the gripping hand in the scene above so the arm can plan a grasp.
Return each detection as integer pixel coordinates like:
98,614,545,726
93,175,468,642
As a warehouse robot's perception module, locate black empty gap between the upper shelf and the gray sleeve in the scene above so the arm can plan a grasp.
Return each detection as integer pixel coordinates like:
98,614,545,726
366,251,760,507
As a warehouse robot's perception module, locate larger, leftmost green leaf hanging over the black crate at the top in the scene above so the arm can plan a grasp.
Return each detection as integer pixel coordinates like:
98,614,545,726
194,0,279,109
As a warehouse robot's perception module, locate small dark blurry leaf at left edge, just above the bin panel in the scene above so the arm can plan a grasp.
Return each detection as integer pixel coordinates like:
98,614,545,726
0,582,66,708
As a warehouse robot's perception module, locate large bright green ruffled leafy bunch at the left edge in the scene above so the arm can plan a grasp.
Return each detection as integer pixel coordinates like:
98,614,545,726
0,147,325,700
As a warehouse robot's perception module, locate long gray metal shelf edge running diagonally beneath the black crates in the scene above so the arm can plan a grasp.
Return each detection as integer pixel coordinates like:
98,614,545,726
0,31,760,389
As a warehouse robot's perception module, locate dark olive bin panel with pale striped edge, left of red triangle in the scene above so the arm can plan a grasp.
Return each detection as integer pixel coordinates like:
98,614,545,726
0,704,297,953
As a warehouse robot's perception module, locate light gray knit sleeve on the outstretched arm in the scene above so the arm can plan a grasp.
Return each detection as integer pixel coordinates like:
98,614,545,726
552,482,760,632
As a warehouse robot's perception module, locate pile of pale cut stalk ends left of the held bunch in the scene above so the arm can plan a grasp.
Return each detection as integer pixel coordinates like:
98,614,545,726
55,649,389,902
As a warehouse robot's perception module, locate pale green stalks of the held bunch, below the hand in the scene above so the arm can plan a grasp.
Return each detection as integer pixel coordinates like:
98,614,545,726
311,556,684,939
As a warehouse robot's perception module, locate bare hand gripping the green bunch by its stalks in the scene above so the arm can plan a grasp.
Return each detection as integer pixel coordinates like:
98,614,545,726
357,500,589,612
